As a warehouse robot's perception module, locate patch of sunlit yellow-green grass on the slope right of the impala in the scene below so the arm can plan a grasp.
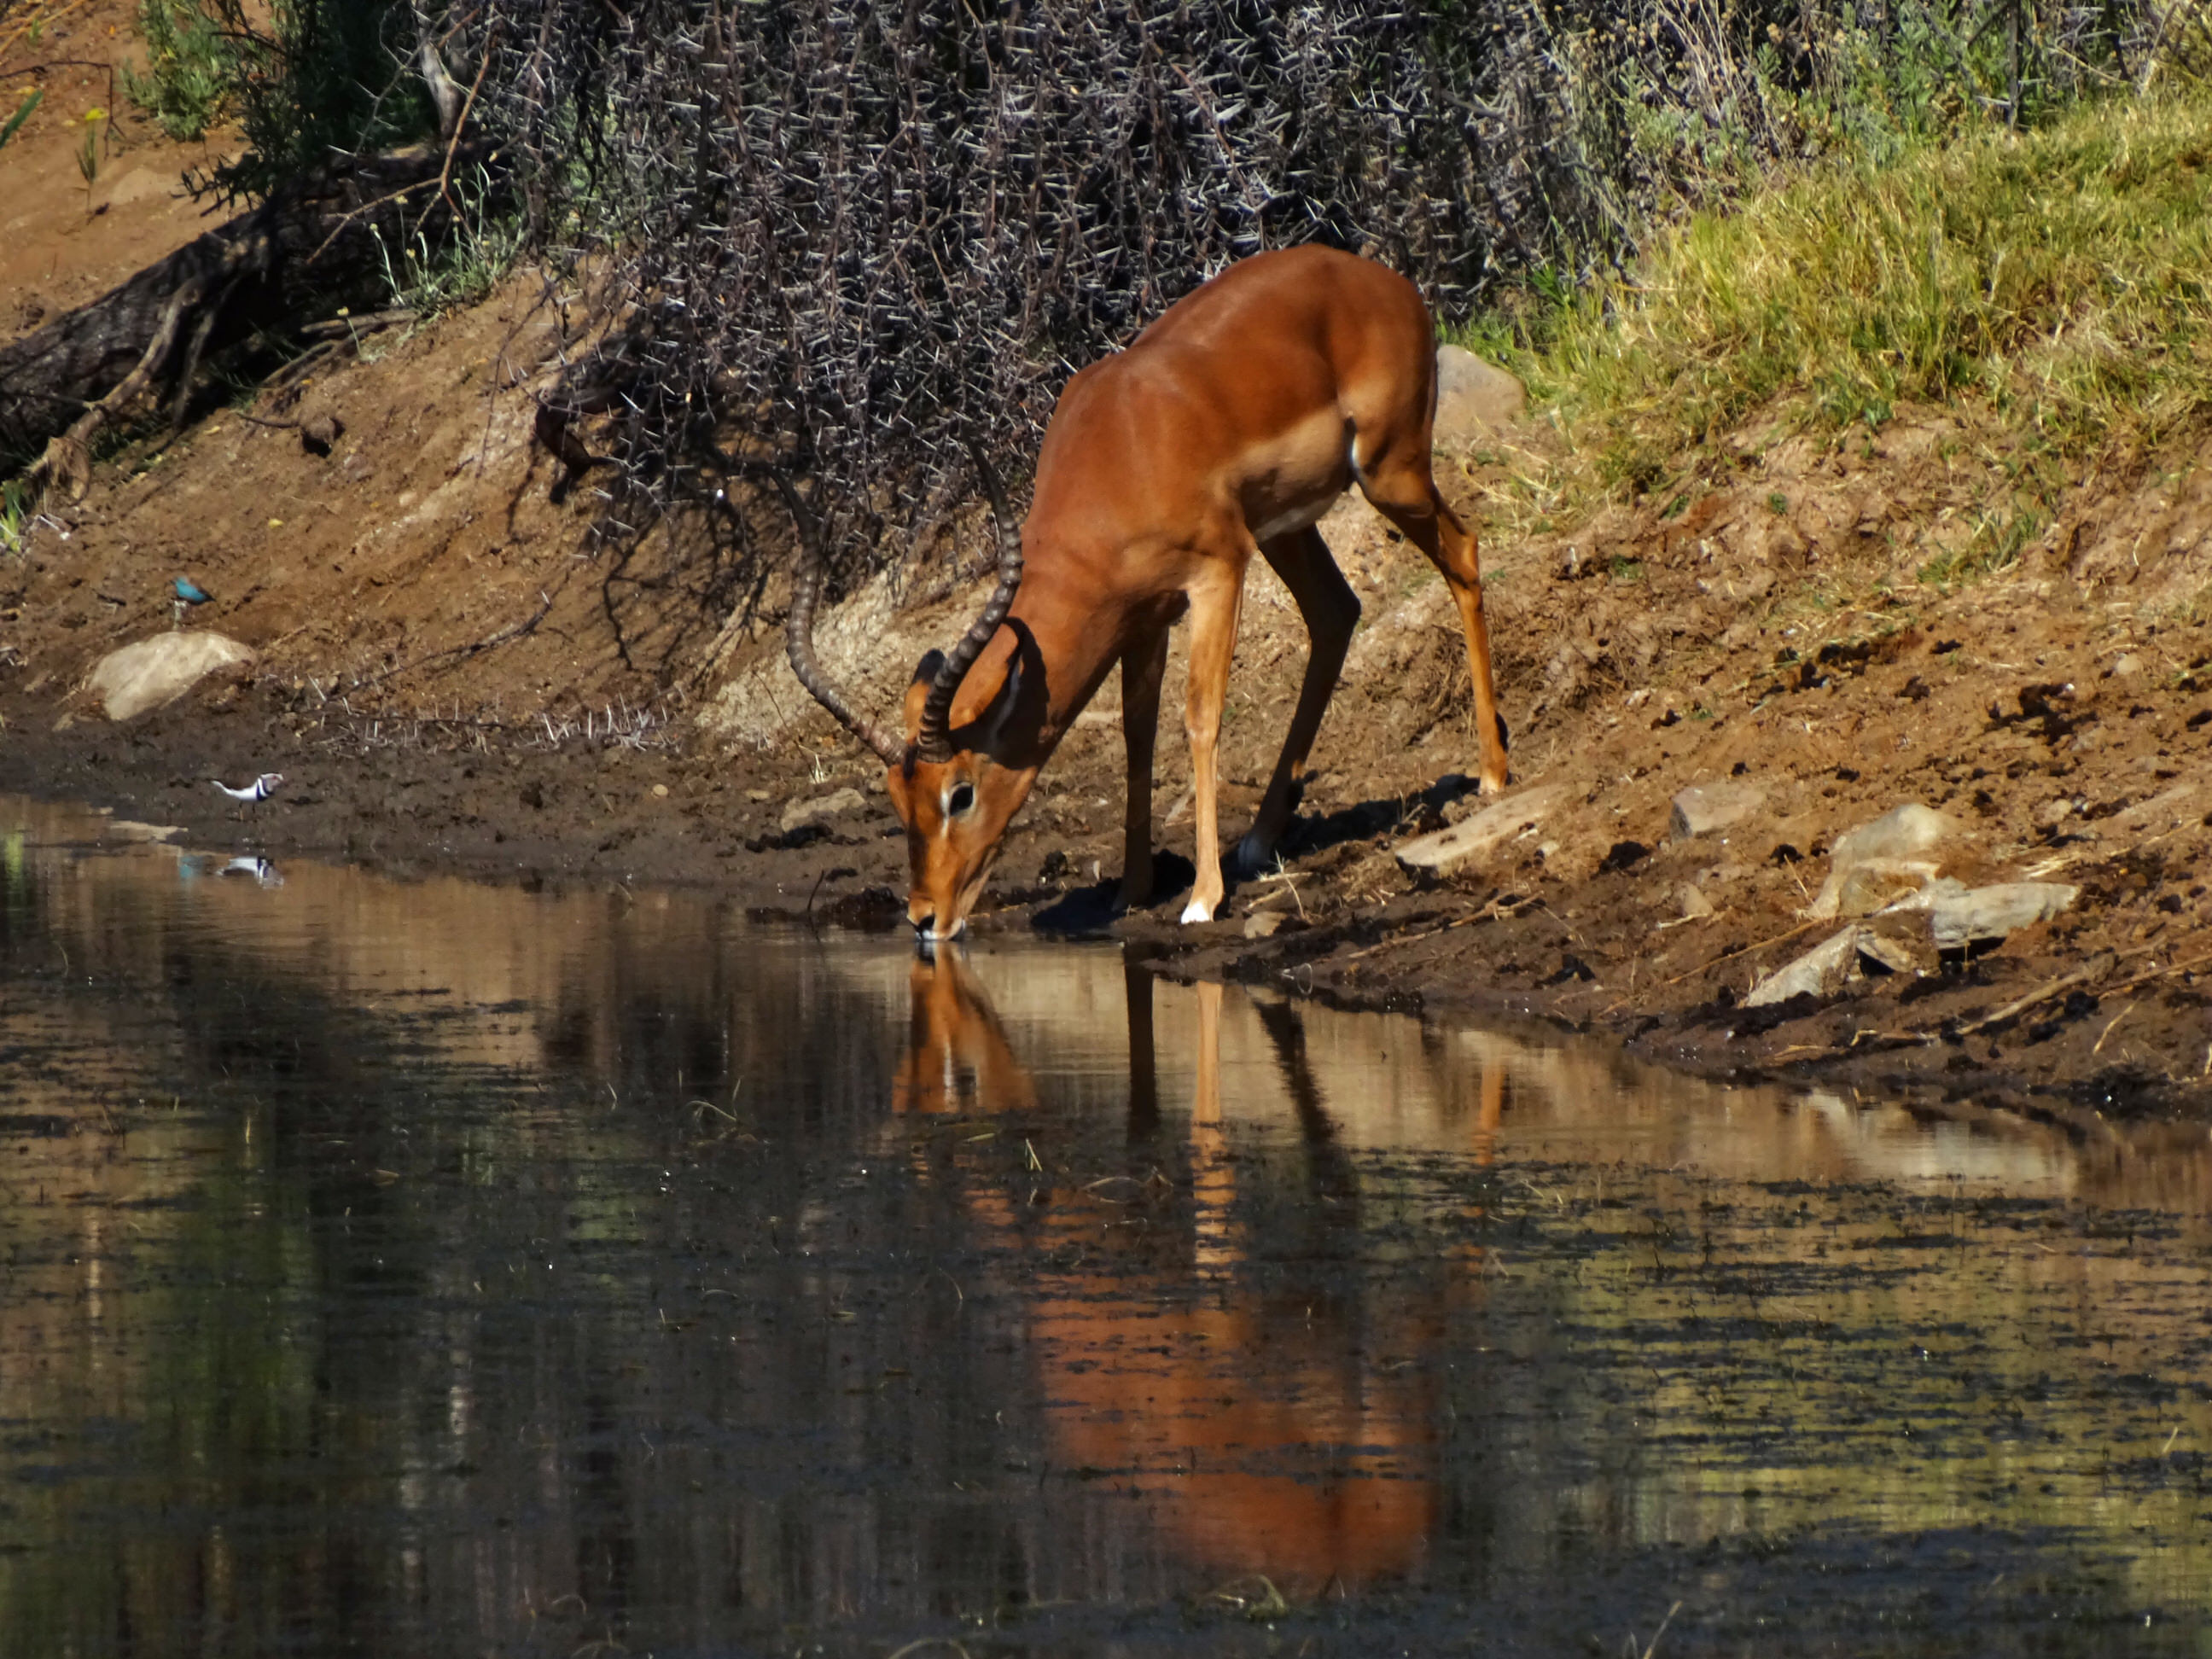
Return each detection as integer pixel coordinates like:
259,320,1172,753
1464,89,2212,480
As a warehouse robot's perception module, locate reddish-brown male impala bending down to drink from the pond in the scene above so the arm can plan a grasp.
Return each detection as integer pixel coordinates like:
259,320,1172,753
785,247,1506,940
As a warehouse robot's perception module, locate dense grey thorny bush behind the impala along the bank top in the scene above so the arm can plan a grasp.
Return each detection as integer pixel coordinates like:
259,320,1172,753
116,0,2212,606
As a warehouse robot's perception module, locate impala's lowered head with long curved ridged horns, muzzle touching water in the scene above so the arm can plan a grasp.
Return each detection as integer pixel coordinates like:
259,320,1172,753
777,453,1038,942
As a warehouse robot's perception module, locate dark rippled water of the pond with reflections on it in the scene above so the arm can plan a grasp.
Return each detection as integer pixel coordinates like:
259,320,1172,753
0,803,2212,1655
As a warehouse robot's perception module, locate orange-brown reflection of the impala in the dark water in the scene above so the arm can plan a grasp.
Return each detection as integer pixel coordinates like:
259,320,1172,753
894,949,1505,1595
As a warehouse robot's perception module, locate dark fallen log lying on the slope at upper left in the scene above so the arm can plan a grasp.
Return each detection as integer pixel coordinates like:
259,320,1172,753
0,146,493,498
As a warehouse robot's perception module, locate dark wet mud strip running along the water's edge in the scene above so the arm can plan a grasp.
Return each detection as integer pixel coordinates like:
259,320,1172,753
0,681,2212,1139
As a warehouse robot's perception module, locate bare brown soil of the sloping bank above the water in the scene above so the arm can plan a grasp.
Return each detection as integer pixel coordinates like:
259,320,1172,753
0,32,2212,1135
